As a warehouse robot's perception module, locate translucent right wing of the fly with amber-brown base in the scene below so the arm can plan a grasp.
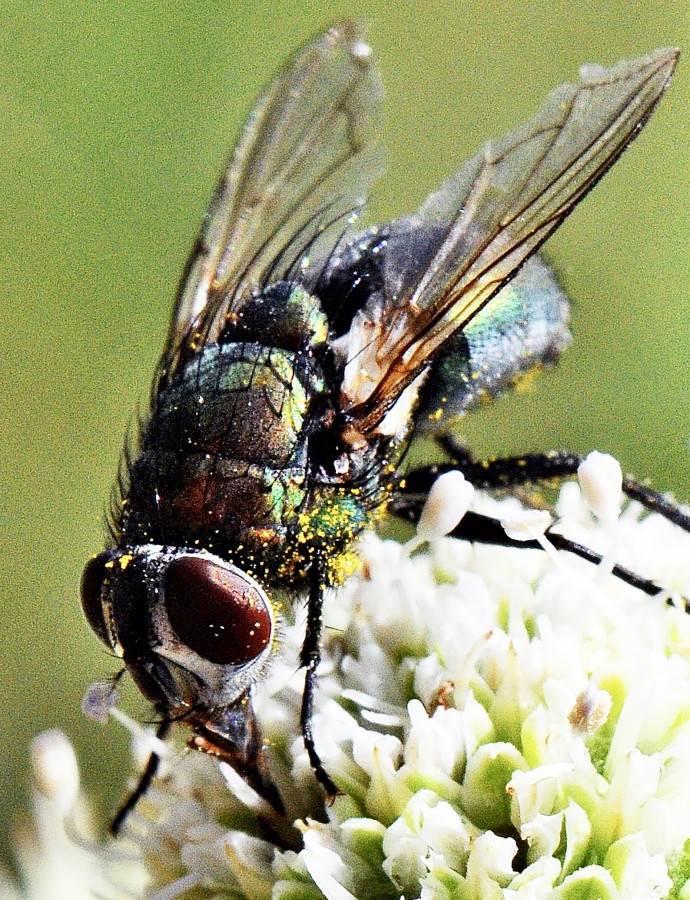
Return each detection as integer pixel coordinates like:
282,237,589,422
336,50,678,435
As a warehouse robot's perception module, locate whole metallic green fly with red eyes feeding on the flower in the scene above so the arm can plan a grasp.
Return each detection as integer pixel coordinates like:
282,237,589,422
82,24,682,829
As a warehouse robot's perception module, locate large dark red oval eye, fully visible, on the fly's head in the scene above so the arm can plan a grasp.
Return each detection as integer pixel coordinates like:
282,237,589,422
165,556,273,666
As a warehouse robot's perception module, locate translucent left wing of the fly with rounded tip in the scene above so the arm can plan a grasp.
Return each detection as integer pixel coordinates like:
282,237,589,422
159,22,382,384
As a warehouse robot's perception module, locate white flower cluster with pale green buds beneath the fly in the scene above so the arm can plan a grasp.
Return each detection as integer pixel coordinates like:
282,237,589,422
10,474,690,900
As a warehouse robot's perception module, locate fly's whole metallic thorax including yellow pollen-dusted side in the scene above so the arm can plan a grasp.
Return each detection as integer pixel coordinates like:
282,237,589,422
121,282,402,586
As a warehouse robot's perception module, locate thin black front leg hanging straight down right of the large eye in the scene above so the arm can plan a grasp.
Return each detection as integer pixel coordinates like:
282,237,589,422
300,562,340,803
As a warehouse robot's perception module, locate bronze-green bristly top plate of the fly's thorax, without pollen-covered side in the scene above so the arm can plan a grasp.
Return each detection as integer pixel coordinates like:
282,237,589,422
125,295,325,549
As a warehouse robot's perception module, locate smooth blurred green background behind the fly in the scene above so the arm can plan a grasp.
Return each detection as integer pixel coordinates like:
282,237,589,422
0,0,690,872
